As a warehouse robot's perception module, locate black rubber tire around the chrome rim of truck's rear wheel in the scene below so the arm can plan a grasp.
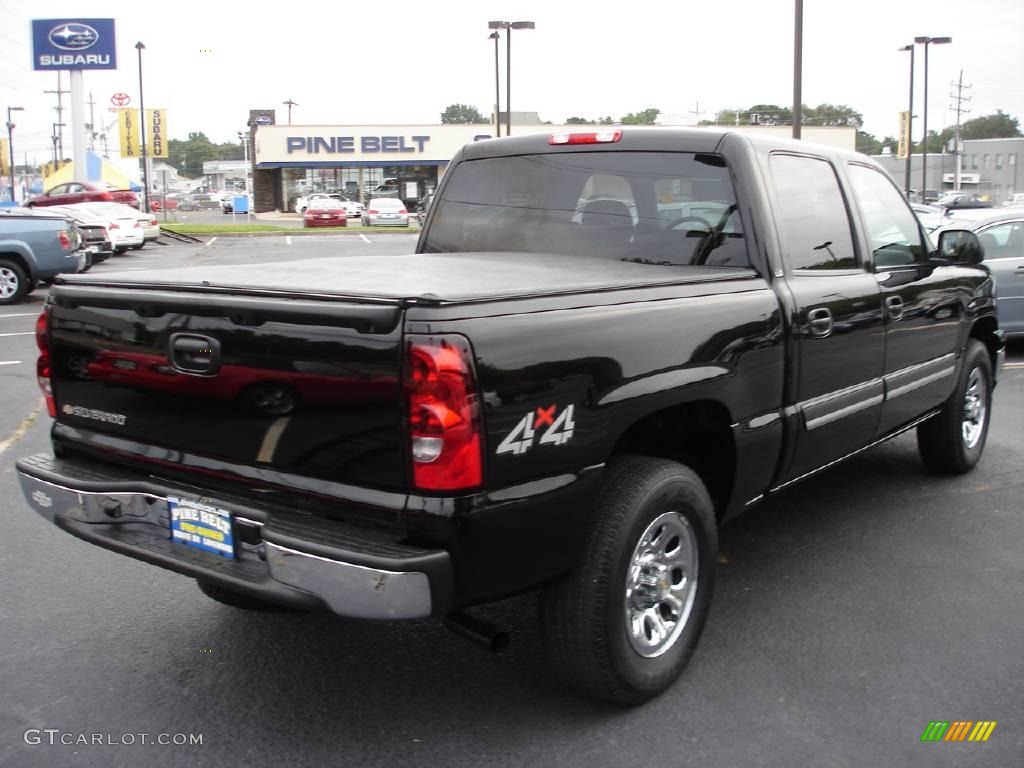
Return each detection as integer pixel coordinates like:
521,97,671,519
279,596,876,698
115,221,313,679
540,456,718,705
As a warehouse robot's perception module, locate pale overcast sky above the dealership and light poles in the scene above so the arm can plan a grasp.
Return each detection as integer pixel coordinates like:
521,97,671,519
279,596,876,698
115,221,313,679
0,0,1024,162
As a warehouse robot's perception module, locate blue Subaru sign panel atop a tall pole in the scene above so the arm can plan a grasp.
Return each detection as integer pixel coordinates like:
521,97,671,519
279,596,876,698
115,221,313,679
32,18,118,71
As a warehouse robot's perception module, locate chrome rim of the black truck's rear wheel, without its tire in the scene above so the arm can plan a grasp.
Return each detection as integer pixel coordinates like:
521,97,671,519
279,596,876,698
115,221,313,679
626,512,698,658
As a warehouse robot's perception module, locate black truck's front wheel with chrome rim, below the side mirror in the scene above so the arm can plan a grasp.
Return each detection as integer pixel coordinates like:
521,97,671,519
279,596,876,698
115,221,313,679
918,339,992,475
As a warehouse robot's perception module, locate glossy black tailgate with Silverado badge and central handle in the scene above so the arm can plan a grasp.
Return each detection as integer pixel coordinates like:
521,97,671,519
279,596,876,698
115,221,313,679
49,284,406,490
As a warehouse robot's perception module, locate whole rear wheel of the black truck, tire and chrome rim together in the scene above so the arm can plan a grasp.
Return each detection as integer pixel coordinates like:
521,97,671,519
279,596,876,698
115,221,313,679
540,456,718,705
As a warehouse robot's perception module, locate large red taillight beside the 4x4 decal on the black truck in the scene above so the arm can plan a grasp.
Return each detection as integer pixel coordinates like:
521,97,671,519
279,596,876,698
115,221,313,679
406,334,483,490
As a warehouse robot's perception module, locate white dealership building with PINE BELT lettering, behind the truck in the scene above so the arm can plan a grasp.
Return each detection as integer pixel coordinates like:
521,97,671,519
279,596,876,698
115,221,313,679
249,110,856,213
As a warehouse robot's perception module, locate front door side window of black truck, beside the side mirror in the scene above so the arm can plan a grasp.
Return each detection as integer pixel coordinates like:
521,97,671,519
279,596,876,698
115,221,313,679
849,164,928,270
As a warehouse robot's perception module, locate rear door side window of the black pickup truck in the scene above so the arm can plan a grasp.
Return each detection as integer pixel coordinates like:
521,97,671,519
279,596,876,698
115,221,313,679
771,155,857,269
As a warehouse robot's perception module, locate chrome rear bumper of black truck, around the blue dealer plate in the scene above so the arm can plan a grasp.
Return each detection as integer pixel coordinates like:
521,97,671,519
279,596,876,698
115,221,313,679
17,455,451,620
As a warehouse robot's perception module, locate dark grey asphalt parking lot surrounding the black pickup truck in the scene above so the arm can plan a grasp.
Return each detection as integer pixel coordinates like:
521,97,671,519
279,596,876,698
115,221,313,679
0,237,1024,768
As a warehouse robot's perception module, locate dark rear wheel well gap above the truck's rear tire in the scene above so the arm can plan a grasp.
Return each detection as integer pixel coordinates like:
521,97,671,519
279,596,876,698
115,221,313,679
612,400,736,519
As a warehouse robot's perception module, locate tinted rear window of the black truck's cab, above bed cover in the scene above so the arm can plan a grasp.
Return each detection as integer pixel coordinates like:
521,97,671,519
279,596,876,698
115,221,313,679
424,152,750,267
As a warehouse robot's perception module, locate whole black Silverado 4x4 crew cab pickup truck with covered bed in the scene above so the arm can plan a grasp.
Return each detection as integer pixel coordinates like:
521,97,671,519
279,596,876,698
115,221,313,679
18,128,1004,703
